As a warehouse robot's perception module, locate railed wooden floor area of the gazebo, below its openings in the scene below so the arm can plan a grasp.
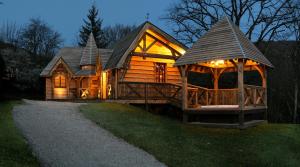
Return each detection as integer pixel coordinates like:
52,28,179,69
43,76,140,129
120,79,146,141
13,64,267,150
186,84,267,111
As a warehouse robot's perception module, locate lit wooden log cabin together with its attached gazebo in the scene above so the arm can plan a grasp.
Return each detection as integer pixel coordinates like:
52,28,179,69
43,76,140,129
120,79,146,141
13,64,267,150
41,17,273,128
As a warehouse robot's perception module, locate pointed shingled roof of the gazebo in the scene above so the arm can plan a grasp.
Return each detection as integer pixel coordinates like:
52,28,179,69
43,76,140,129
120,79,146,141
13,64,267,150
175,17,273,67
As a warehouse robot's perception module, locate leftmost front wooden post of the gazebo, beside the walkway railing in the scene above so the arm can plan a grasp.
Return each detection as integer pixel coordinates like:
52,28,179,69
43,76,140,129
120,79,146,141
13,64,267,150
180,65,188,122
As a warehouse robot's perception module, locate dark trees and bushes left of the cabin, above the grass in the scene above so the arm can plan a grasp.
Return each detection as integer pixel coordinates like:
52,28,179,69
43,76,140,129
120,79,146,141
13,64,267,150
0,18,62,99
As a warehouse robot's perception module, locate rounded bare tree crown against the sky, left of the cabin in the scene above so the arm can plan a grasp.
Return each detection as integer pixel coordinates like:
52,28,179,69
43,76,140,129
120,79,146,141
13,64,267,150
21,18,62,56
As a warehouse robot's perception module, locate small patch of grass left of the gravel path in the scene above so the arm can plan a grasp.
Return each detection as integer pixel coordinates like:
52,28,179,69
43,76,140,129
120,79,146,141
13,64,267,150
0,101,39,167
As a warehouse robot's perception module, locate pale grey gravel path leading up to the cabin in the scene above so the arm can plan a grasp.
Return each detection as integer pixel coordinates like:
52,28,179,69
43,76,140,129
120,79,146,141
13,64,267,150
13,100,165,167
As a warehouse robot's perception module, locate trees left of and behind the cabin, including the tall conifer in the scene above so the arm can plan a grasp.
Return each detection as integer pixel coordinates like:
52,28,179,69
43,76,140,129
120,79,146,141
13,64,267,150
0,4,135,100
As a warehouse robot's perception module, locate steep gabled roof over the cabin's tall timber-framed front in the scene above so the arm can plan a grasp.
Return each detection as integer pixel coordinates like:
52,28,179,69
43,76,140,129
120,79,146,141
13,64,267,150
105,21,187,69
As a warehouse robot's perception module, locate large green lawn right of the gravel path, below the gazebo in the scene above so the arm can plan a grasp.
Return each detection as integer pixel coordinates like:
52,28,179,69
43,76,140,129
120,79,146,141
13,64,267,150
81,103,300,167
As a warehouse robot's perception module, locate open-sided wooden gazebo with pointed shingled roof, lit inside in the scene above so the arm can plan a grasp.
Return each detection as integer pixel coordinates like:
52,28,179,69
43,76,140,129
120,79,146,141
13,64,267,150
175,17,273,127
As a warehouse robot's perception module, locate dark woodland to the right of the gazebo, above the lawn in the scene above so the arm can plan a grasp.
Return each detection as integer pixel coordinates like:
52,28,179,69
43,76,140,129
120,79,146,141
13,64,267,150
259,41,300,123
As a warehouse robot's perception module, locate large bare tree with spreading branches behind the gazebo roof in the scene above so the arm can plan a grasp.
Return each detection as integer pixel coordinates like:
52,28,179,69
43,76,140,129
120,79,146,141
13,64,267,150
163,0,299,44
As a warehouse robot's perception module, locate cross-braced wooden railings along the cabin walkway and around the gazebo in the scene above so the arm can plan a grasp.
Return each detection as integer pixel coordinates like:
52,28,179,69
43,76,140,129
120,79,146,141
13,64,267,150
118,82,266,108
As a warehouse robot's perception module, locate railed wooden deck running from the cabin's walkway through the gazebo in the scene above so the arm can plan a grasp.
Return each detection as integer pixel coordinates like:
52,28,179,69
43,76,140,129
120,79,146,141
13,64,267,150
113,82,267,112
